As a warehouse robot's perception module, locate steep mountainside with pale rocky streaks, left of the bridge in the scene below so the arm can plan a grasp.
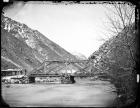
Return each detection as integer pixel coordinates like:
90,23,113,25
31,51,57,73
1,15,77,71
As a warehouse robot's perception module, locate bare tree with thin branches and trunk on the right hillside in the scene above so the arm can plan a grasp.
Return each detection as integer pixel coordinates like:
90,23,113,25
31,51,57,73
106,2,136,64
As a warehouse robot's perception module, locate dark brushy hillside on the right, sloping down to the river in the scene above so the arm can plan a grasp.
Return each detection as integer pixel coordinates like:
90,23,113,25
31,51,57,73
89,25,138,104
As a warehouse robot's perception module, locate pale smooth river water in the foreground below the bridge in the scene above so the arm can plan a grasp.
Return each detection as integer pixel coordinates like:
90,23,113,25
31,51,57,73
2,80,116,107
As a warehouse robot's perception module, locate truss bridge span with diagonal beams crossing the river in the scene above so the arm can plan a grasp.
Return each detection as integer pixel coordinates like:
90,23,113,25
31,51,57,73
27,60,94,82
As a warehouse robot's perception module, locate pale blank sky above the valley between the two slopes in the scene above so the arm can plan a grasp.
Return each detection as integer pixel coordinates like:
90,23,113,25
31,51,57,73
5,2,118,57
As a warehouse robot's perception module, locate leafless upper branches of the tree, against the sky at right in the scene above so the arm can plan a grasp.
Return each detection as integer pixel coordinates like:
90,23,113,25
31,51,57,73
106,2,135,34
